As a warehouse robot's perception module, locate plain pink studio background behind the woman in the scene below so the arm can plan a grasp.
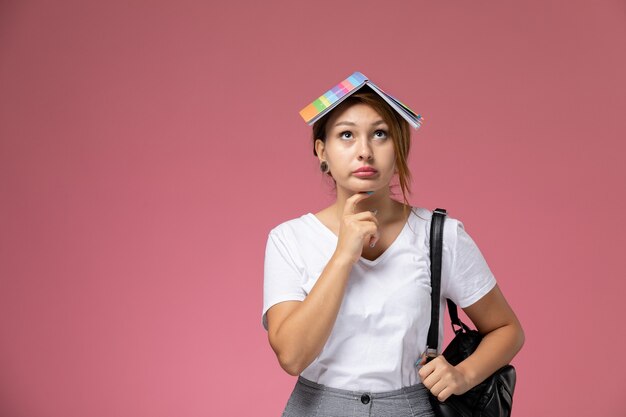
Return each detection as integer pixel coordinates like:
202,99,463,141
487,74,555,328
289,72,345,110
0,0,626,417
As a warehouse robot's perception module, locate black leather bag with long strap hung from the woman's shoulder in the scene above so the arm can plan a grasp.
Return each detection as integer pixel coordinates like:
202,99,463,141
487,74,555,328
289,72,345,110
426,208,515,417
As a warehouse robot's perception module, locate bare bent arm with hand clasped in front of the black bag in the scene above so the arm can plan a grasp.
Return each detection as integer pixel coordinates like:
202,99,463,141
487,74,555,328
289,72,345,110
419,285,524,401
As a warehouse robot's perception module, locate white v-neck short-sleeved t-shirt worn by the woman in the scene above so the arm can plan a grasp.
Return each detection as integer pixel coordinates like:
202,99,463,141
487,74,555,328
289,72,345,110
262,207,496,392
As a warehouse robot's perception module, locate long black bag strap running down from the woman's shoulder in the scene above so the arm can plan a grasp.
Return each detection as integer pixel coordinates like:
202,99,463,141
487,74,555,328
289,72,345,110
426,208,444,360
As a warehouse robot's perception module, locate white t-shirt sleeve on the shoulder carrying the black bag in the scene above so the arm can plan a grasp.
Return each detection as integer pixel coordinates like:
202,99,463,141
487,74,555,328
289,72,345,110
442,219,496,308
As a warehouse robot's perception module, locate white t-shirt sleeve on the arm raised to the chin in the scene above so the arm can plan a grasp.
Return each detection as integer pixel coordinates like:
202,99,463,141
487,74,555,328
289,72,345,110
262,231,306,330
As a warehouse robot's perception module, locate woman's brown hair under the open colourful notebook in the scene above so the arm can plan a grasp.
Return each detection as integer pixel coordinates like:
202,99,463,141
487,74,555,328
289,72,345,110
312,91,411,214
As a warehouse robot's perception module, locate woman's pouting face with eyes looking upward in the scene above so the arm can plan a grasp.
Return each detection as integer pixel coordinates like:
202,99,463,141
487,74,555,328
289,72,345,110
315,103,395,193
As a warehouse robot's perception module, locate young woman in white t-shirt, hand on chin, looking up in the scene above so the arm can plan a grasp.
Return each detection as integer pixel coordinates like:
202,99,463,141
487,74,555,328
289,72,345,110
263,75,524,417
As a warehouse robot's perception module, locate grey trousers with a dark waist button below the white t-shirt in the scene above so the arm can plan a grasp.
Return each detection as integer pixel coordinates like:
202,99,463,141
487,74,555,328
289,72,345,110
282,376,435,417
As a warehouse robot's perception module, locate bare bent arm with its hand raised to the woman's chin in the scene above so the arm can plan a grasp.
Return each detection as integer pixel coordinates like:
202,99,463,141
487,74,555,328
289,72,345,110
267,194,379,376
